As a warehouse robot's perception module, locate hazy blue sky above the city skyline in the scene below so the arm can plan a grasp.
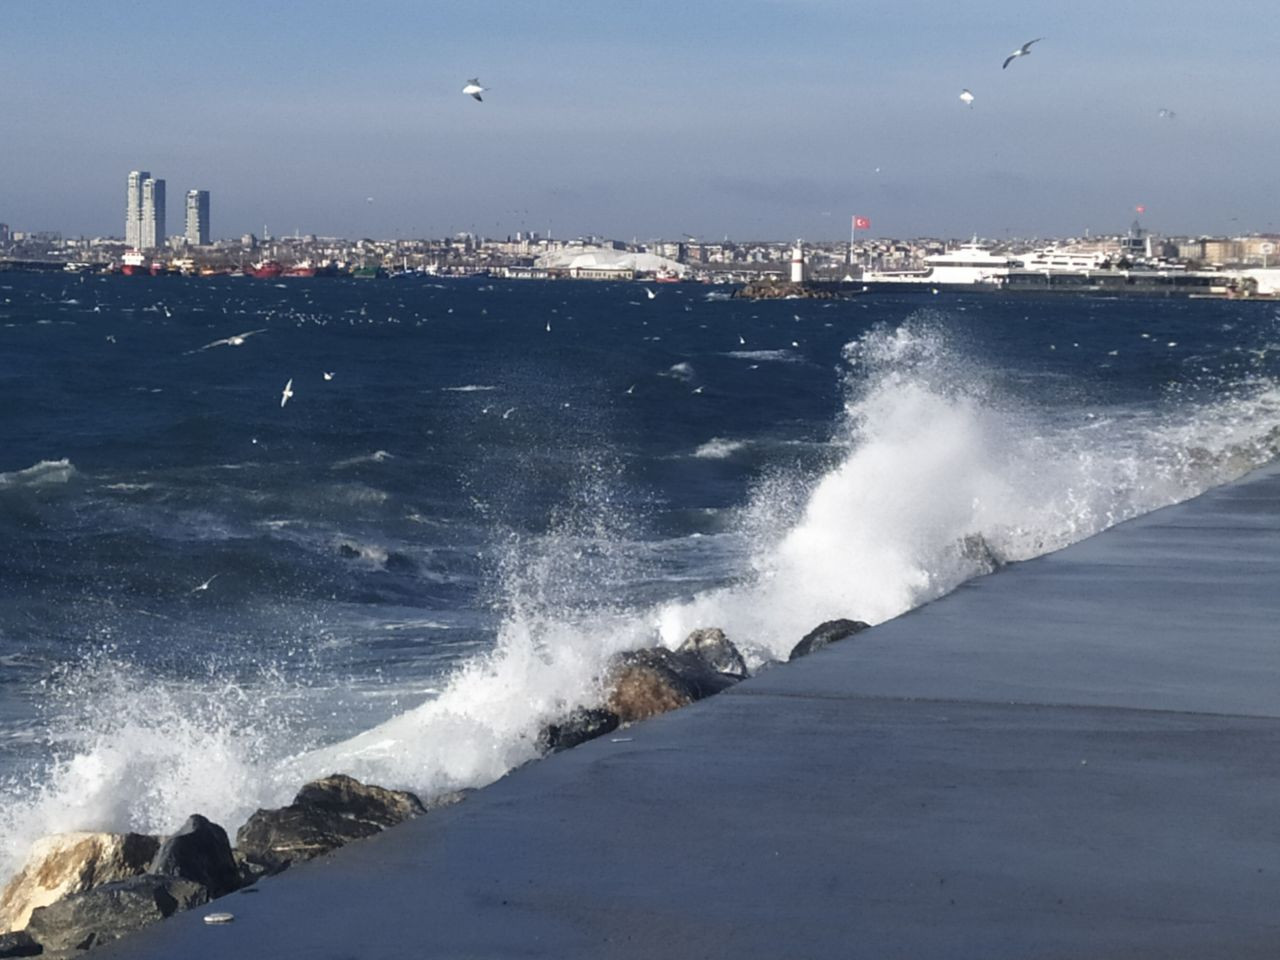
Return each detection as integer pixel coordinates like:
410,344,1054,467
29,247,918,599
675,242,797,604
0,0,1280,239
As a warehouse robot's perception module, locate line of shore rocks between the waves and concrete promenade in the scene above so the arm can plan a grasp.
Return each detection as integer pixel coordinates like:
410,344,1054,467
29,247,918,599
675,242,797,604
0,620,868,960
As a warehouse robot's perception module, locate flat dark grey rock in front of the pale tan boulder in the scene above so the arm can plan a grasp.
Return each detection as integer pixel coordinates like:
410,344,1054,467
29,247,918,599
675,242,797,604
27,873,209,956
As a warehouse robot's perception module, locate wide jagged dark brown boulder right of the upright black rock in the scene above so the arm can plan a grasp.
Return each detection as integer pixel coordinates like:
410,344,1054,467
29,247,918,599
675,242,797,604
236,773,426,872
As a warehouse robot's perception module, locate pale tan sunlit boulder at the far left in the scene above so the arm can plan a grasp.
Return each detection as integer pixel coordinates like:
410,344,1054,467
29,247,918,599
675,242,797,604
0,833,160,933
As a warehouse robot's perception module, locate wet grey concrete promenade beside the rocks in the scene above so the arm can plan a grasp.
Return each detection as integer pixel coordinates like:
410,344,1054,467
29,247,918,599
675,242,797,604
104,465,1280,960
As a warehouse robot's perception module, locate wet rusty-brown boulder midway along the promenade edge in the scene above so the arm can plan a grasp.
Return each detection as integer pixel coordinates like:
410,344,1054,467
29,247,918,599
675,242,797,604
604,646,741,723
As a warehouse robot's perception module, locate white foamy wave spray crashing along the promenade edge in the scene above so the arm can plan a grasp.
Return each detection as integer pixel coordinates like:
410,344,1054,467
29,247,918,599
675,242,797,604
0,323,1280,874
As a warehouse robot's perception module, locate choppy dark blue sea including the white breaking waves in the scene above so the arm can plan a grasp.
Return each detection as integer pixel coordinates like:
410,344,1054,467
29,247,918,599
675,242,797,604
0,273,1280,881
